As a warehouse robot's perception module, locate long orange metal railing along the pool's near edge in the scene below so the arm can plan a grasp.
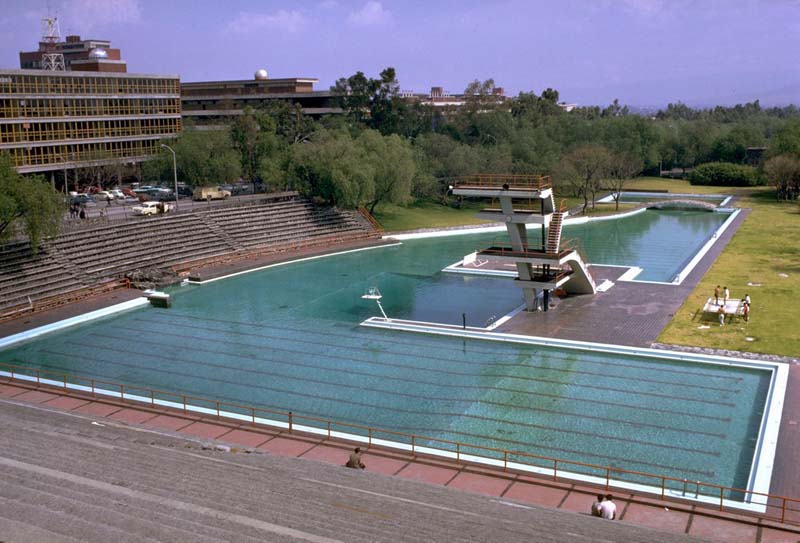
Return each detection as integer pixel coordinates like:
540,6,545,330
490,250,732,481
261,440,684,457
0,363,800,526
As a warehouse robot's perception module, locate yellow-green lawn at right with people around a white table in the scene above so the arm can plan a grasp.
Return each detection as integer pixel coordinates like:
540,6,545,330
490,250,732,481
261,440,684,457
659,187,800,357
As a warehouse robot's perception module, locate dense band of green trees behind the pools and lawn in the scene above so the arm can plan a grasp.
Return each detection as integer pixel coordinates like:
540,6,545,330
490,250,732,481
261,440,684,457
145,68,800,209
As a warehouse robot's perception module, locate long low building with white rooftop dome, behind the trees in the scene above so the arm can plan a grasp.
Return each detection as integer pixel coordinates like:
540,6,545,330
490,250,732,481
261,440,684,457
181,70,341,127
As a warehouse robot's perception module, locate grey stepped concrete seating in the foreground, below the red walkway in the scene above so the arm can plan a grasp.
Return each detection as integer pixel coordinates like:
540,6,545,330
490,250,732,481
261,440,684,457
0,400,708,543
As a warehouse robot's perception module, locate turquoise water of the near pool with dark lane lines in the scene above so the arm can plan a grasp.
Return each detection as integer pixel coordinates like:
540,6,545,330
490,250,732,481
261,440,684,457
2,209,770,492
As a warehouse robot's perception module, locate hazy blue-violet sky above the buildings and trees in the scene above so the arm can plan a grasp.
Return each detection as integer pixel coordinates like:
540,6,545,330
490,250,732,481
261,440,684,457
0,0,800,105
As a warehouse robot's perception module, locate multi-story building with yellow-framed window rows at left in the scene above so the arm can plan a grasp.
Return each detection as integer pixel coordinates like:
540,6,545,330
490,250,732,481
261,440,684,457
0,70,181,180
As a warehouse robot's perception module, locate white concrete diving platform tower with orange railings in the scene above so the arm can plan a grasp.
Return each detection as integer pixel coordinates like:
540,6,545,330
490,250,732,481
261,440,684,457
452,174,597,311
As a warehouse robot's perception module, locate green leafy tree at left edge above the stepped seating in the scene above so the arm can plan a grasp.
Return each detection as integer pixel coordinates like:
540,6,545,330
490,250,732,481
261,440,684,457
0,153,66,253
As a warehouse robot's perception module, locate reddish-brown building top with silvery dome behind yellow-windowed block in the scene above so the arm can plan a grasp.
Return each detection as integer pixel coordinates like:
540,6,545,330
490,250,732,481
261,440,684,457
19,36,128,73
